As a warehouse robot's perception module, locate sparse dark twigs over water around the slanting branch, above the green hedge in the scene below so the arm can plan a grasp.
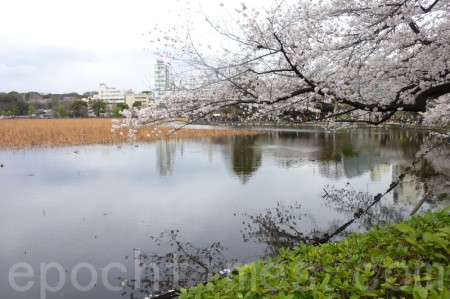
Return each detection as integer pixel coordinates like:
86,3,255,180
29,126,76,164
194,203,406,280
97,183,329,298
241,198,406,256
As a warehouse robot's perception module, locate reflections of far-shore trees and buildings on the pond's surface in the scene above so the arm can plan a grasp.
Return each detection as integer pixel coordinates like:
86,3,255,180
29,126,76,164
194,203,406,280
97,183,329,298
150,129,436,184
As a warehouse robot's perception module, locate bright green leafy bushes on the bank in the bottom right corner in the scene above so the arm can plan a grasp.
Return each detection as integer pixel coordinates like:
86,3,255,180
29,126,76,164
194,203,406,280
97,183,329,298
180,207,450,299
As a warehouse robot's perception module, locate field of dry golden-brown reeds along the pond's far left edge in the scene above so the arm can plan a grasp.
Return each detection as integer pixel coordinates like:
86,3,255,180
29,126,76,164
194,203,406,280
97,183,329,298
0,119,260,148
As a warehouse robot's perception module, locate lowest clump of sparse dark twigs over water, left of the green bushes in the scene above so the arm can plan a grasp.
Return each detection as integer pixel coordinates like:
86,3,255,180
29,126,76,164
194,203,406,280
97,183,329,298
119,230,236,298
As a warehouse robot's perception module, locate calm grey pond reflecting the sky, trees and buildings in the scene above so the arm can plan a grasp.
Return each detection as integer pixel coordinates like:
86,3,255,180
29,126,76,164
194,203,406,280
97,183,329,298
0,128,450,299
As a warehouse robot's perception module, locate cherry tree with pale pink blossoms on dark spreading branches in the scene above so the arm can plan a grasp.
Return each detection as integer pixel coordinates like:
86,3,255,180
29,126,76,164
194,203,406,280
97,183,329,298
123,0,450,124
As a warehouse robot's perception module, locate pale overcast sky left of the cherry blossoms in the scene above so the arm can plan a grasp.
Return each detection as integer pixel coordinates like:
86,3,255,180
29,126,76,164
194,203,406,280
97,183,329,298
0,0,273,93
